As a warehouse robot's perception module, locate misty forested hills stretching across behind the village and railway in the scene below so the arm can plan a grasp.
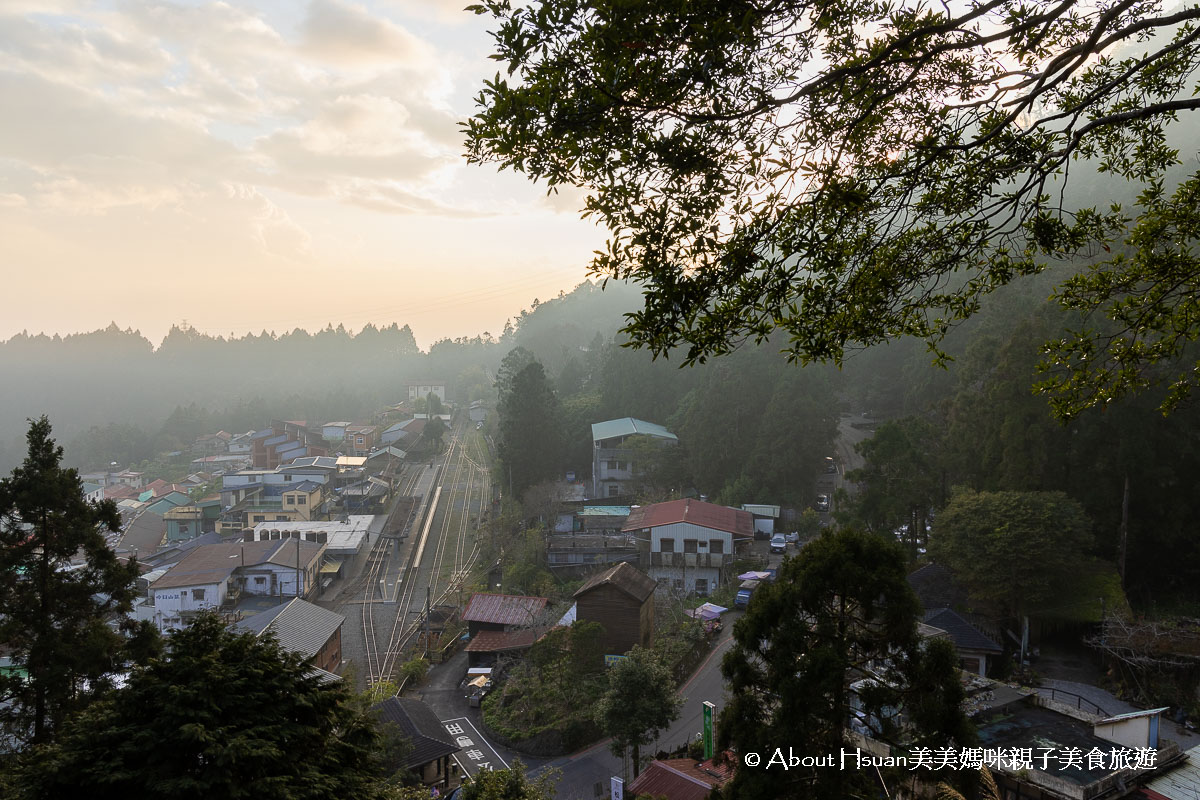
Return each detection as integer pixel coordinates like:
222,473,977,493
0,270,1200,603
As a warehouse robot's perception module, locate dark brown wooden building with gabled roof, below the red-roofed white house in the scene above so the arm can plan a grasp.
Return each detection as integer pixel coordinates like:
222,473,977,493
575,564,658,655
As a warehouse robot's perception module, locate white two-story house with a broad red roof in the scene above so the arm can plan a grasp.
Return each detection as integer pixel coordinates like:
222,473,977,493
622,499,754,595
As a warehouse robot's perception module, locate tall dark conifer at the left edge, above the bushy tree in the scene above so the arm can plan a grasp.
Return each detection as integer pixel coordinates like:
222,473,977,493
0,416,138,744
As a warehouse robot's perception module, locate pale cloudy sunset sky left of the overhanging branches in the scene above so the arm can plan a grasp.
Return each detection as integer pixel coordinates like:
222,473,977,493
0,0,604,347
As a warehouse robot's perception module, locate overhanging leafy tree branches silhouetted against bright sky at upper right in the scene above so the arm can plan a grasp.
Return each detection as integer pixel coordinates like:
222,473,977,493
464,0,1200,416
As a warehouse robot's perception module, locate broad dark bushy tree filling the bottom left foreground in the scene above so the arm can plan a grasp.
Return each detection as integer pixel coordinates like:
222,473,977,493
17,614,385,800
